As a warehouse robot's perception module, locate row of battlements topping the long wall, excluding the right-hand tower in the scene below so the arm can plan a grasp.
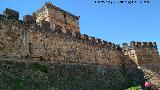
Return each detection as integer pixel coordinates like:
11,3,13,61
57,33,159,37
0,8,121,50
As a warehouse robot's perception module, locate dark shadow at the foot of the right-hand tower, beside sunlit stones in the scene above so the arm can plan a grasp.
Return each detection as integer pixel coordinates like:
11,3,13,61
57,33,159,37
122,58,146,89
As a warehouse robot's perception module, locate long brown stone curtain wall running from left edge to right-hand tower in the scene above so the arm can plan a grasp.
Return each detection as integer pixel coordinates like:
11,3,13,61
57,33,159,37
0,10,122,66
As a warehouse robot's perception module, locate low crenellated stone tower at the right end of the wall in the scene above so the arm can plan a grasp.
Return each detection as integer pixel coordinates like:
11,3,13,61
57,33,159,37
123,41,159,65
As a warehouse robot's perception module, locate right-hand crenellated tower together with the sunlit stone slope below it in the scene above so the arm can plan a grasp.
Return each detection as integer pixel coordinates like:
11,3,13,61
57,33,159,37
122,41,160,90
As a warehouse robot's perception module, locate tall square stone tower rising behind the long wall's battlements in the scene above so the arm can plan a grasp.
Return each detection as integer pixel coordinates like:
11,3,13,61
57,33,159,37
34,2,80,35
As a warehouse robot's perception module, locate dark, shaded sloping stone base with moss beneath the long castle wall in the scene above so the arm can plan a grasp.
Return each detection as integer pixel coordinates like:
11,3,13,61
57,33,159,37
0,59,140,90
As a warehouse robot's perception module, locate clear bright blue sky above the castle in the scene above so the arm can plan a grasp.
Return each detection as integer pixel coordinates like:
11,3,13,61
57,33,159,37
0,0,160,49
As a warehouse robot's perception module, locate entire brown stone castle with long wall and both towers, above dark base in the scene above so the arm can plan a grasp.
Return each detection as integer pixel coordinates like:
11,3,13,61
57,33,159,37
0,2,159,67
